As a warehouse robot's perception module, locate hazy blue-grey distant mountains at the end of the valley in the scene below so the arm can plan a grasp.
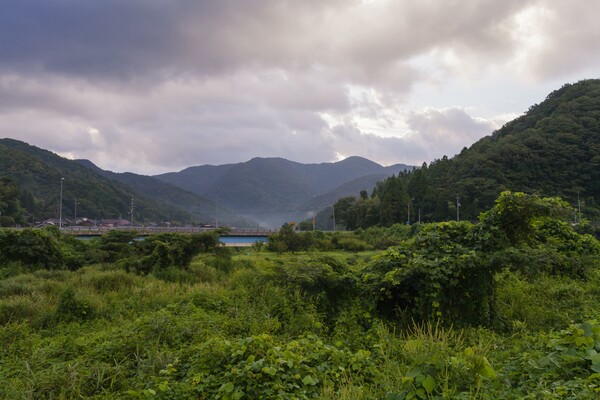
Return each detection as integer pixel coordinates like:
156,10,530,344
155,157,413,226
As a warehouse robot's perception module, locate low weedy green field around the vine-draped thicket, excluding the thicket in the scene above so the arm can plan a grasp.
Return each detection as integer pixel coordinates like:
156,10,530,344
0,245,600,399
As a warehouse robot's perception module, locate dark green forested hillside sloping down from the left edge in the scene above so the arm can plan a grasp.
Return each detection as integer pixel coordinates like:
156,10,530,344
0,139,213,226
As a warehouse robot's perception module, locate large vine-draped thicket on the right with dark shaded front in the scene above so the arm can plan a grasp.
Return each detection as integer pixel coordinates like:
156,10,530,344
362,192,599,325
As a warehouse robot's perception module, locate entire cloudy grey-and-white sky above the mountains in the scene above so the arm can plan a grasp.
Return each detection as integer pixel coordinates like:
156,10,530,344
0,0,600,174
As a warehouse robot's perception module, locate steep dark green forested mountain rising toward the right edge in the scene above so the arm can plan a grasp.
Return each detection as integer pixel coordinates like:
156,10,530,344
336,79,600,228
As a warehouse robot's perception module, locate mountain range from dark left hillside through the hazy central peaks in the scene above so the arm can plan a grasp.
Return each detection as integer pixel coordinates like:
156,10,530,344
0,138,412,227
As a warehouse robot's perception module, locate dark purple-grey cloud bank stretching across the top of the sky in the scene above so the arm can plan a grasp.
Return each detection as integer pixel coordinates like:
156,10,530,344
0,0,526,86
